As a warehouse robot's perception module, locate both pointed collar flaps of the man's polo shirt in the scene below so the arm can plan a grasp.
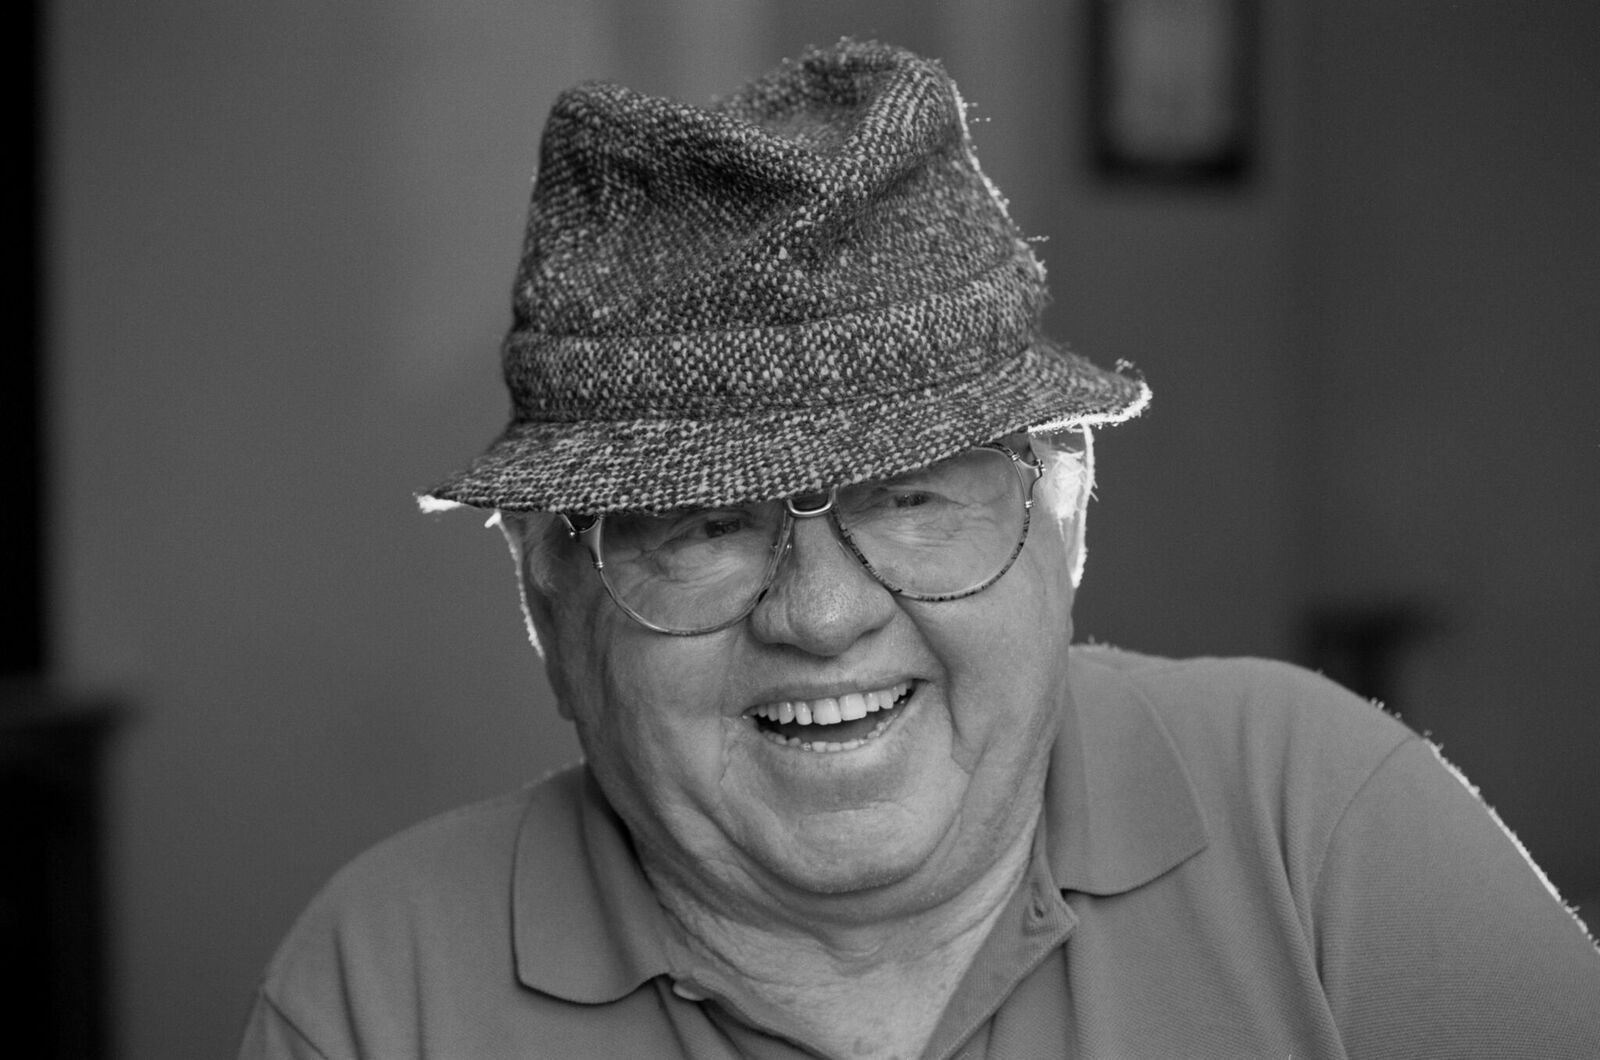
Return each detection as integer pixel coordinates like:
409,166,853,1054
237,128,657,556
512,648,1205,1004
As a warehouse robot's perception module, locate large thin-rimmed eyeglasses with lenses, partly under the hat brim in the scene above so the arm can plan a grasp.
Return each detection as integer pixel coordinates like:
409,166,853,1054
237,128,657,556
562,442,1043,636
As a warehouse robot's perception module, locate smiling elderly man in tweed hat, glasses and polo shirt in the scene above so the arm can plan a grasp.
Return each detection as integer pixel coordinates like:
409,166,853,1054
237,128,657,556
243,42,1600,1060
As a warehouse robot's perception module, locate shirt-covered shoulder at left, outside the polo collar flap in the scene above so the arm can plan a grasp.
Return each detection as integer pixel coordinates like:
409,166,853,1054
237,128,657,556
248,765,627,1057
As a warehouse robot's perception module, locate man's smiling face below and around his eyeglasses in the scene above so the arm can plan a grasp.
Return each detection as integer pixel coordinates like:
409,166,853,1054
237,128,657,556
526,464,1072,913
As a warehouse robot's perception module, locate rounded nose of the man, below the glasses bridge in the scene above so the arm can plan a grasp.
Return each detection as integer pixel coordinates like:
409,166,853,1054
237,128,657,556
750,519,898,656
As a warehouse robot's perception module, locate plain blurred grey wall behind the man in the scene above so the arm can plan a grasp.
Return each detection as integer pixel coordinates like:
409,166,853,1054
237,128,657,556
40,0,1600,1060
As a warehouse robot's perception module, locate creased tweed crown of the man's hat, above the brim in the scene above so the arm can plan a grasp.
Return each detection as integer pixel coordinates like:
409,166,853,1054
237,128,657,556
506,42,1043,418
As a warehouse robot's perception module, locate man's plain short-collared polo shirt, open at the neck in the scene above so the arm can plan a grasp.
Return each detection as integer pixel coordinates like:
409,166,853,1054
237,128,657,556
240,647,1600,1060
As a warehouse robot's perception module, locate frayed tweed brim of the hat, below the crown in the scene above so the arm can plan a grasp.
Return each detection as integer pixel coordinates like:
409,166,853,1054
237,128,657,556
422,341,1150,514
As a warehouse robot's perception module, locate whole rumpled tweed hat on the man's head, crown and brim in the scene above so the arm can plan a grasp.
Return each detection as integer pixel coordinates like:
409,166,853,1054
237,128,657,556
429,40,1149,512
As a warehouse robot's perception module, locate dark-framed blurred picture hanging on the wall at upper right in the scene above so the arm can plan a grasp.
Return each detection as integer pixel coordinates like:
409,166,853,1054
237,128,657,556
1086,0,1259,186
